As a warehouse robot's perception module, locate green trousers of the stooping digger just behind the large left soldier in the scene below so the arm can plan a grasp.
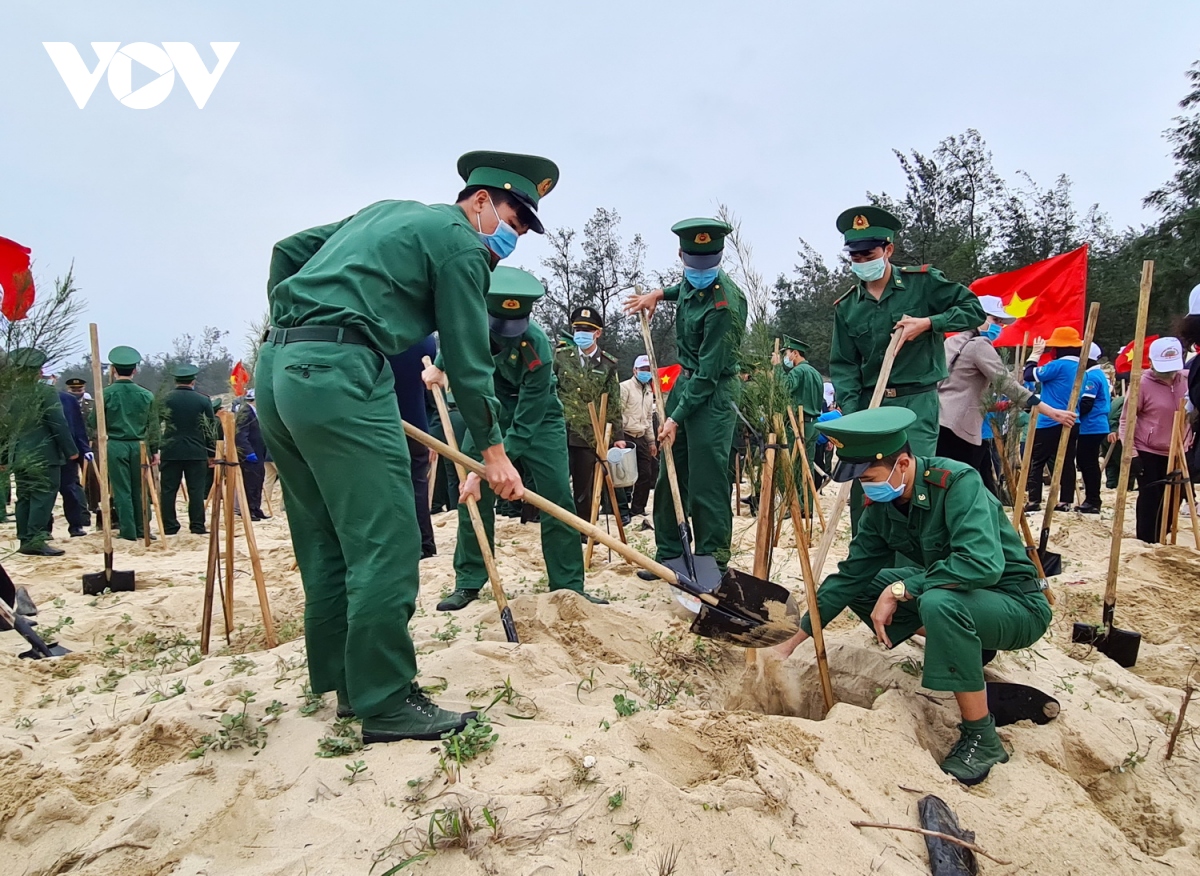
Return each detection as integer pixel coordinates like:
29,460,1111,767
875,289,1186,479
454,403,583,593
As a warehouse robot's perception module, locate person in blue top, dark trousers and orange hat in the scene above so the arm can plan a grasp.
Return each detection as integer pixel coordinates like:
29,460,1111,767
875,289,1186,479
1025,325,1084,511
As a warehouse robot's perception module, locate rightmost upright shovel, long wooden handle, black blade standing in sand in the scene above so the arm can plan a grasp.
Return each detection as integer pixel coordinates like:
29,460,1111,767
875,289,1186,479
1070,259,1154,670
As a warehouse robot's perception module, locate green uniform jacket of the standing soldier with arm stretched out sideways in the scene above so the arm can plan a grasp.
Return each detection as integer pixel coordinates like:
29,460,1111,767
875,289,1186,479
662,270,744,427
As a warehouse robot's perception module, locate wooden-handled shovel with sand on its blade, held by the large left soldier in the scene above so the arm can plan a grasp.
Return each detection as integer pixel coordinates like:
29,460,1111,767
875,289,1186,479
404,422,800,648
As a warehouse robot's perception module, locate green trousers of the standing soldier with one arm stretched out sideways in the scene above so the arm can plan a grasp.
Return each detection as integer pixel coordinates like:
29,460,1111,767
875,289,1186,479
654,380,737,571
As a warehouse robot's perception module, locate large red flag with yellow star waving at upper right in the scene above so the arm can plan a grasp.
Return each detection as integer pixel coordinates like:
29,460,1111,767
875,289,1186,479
971,244,1087,347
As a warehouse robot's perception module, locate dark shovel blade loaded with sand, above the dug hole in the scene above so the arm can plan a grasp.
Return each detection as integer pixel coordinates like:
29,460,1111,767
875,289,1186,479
691,569,800,648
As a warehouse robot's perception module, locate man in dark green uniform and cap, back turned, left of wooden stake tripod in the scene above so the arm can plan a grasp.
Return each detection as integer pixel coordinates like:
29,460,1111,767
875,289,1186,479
161,364,218,535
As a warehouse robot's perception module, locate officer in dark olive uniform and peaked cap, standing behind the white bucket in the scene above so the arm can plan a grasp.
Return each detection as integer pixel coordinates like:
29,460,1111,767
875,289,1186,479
554,305,629,523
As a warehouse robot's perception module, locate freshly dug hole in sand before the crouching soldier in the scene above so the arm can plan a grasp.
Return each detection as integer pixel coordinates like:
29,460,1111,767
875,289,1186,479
724,638,898,721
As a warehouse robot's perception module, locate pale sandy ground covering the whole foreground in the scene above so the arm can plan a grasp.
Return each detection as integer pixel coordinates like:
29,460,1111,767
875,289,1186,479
0,484,1200,876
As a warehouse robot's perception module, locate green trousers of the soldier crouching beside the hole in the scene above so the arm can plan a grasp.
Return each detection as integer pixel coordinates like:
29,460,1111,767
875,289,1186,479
822,566,1050,692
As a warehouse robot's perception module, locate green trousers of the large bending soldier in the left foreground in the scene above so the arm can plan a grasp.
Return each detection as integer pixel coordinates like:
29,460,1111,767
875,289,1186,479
256,341,421,718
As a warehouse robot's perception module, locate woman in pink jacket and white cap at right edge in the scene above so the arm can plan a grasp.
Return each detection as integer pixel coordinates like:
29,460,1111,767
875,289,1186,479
1121,337,1192,544
